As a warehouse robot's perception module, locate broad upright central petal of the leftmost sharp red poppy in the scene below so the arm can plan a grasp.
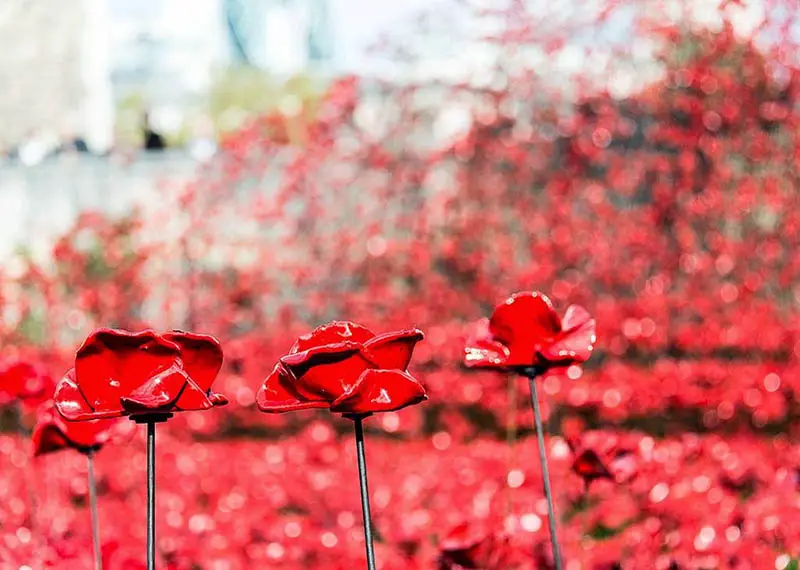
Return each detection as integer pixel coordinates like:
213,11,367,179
75,329,180,415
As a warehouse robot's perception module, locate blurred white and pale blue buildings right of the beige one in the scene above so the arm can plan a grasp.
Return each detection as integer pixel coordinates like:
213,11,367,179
104,0,332,96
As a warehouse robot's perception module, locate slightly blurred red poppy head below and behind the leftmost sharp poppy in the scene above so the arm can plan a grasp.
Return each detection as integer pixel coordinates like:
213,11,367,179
33,398,113,455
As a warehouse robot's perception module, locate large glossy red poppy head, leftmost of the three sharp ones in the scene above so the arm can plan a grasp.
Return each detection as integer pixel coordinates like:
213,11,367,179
54,329,228,421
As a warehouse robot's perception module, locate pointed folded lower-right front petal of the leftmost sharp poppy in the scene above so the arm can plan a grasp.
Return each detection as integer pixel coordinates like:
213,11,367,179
120,364,200,414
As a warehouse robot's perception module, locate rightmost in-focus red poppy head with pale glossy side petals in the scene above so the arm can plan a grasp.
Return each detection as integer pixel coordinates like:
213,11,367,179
464,292,595,369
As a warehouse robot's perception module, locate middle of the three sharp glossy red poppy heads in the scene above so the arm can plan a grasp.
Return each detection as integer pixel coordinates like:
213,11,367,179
257,321,428,414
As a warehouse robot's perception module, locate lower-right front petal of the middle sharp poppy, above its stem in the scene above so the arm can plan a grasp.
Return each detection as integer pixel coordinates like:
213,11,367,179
331,370,428,414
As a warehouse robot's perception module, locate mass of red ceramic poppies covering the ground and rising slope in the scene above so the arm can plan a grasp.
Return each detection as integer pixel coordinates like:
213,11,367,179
0,0,800,570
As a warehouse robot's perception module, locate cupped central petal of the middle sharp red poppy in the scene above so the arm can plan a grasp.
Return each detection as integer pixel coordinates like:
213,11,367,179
281,342,372,402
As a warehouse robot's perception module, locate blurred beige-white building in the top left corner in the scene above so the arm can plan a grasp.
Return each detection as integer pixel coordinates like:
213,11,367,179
0,0,113,153
